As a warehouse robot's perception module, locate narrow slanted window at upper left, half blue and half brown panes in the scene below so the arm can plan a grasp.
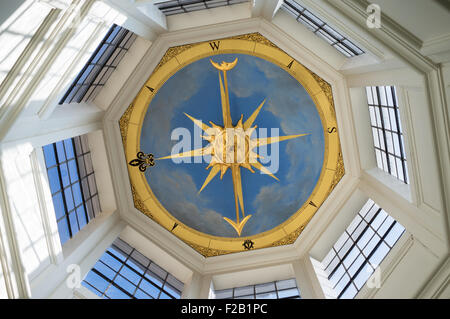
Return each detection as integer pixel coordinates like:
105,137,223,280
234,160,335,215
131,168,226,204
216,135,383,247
59,24,137,104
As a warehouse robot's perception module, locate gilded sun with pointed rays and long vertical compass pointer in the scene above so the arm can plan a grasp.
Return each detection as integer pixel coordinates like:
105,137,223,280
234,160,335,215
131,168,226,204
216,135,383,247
158,58,308,236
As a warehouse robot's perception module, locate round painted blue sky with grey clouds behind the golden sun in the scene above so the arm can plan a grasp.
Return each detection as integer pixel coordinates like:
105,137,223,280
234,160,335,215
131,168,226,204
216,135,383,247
141,54,324,237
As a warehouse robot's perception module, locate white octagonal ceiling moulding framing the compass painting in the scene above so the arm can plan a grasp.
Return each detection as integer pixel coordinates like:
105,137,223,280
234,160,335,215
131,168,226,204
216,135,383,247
104,18,360,274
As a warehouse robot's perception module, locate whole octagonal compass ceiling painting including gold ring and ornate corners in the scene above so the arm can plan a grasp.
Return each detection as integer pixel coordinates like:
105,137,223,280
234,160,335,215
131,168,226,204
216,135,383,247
119,33,344,257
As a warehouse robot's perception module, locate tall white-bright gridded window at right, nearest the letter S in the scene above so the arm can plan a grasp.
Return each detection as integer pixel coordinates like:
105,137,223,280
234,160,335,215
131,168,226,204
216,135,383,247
366,86,409,184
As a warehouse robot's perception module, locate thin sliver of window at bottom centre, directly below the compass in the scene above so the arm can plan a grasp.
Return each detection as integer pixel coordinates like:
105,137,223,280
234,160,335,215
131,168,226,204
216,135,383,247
214,279,300,299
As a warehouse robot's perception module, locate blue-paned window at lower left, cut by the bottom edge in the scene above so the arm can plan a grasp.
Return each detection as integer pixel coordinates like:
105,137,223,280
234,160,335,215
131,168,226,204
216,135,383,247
82,238,184,299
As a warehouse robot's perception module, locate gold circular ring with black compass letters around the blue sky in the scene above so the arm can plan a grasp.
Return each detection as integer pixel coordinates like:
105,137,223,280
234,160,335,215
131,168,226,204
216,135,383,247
125,38,340,255
